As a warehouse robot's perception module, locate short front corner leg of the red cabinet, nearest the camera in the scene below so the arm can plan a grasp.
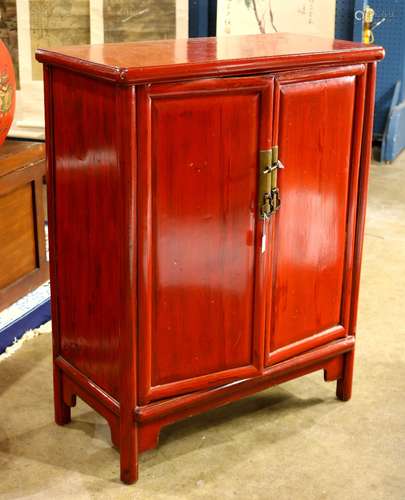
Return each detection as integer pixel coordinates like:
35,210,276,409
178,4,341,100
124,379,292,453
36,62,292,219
120,421,138,484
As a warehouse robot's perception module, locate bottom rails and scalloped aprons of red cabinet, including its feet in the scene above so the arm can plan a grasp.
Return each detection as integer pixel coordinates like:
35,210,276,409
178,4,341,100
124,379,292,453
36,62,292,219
55,336,355,483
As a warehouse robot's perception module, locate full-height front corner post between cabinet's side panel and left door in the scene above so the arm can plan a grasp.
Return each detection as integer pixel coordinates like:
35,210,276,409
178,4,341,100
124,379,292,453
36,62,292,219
115,87,140,484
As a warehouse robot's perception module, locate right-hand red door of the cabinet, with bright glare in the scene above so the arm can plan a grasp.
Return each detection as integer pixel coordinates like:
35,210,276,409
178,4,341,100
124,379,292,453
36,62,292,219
266,65,365,365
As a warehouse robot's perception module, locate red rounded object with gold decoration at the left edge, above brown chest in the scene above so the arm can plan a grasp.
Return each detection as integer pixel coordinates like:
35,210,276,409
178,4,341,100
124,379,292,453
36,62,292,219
0,40,15,145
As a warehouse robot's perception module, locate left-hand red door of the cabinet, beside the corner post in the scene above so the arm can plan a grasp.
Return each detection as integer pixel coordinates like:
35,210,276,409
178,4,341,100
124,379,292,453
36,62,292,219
138,77,273,403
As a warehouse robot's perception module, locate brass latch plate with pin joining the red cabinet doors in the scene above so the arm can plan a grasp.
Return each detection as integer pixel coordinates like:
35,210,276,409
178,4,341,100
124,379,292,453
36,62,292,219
259,146,284,219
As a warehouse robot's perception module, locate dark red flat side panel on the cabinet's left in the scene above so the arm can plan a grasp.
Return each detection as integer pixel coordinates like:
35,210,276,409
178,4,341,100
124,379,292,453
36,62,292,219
52,68,120,399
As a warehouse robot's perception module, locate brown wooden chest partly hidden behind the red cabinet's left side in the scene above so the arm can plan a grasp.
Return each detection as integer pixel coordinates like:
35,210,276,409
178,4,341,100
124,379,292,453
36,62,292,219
0,140,48,311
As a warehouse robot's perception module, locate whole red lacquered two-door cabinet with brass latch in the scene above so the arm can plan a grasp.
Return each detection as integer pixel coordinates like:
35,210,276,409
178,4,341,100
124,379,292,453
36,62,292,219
37,34,383,483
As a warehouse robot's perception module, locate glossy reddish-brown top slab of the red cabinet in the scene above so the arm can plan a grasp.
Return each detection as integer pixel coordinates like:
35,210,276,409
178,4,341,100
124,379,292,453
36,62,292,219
36,33,384,83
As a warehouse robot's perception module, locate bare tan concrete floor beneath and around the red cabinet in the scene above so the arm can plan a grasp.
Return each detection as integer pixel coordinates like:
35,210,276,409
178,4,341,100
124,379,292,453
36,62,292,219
0,155,405,500
